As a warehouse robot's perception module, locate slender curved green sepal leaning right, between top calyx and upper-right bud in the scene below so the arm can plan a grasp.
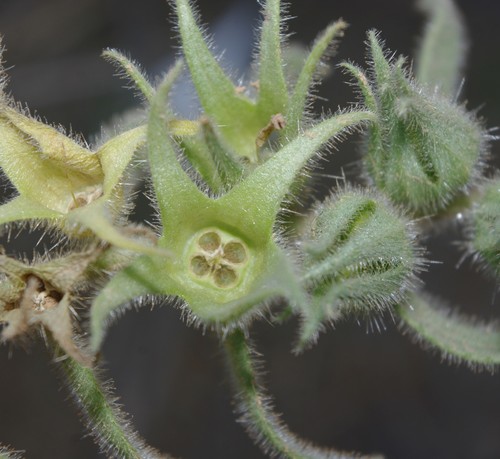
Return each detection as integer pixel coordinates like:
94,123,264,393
281,20,350,139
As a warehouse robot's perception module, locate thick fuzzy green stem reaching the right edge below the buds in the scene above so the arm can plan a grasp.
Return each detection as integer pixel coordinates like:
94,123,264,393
397,294,500,370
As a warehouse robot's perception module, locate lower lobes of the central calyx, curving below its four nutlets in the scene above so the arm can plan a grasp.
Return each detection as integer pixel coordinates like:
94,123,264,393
90,246,305,352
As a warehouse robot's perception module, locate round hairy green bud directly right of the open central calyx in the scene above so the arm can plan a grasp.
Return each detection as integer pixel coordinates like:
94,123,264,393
302,189,421,344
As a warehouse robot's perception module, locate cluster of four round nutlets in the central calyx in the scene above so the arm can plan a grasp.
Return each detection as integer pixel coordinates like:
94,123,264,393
188,228,249,289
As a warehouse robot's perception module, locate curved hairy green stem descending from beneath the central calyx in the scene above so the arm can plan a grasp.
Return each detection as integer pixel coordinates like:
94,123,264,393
224,330,381,459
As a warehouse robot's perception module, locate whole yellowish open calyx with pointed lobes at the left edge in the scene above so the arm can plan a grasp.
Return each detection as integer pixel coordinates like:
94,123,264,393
0,107,147,246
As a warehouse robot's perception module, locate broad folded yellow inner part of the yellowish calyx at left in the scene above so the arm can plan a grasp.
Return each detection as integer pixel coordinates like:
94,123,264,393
0,106,104,214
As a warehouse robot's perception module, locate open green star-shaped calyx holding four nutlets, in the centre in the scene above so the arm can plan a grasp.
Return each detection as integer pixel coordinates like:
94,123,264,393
91,45,373,351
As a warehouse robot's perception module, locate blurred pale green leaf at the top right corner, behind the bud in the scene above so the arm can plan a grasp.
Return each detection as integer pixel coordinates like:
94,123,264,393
415,0,467,99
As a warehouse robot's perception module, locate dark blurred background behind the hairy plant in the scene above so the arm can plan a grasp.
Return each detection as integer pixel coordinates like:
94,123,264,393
0,0,500,459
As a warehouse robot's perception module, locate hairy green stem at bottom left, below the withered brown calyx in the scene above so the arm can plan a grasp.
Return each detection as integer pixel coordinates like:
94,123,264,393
56,349,169,459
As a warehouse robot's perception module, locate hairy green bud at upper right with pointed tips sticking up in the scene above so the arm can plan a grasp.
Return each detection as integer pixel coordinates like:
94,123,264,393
348,33,484,215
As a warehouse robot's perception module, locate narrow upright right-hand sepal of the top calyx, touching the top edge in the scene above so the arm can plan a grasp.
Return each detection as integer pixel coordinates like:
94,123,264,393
257,0,288,118
